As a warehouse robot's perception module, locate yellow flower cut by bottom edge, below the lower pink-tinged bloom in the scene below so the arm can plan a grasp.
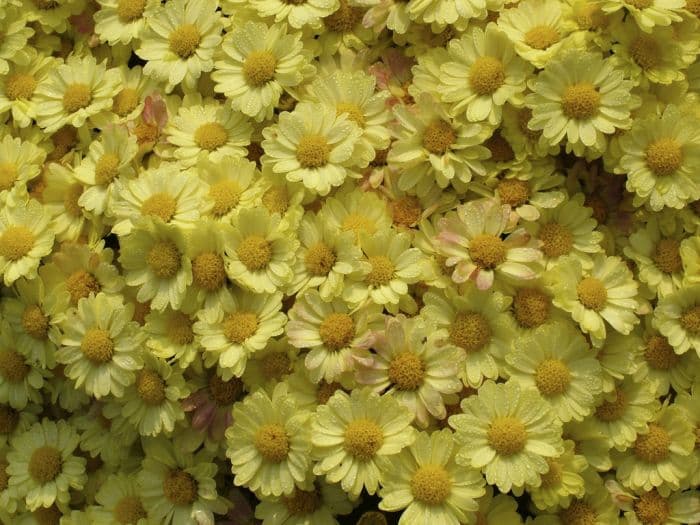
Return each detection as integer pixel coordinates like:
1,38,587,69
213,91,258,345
379,429,484,525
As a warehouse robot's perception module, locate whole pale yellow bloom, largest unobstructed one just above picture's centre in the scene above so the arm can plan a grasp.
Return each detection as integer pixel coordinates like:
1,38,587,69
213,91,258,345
262,103,360,196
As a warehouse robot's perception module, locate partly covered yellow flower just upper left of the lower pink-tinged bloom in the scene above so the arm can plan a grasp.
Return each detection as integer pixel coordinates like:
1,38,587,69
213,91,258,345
287,290,382,383
